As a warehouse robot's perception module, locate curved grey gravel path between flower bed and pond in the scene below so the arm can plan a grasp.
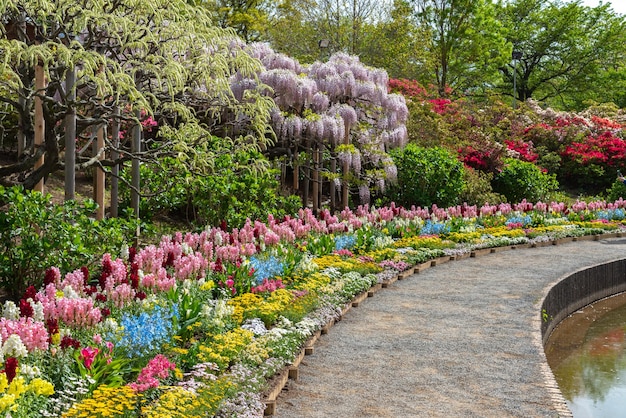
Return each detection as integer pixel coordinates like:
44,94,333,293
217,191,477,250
266,234,626,418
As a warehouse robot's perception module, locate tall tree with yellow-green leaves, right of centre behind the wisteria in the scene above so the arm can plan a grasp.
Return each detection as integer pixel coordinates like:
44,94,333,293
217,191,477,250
414,0,511,97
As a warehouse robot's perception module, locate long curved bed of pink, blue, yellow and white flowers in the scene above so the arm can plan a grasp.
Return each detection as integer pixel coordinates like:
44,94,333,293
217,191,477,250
0,201,626,417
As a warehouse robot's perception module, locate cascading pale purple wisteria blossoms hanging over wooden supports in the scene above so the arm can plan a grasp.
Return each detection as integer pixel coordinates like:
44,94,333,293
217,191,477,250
233,44,408,203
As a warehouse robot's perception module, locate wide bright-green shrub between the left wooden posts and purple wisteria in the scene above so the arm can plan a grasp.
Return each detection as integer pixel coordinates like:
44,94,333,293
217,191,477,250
122,151,302,228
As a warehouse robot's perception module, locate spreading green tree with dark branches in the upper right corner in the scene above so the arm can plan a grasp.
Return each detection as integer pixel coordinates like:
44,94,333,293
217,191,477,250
498,0,626,109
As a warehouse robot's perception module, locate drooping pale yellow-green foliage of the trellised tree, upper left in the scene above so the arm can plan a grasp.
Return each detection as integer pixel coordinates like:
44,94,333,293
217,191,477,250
0,0,273,188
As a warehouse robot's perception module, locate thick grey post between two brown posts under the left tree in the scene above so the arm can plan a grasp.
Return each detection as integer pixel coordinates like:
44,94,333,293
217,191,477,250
65,68,76,201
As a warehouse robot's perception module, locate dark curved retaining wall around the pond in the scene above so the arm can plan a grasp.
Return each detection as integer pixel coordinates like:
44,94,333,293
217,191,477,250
541,259,626,346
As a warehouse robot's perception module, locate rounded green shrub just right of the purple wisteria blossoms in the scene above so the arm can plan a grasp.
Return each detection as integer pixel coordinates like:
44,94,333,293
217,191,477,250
385,144,465,207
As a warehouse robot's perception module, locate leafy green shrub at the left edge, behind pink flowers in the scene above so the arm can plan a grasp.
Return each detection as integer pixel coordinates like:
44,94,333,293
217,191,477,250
0,186,137,300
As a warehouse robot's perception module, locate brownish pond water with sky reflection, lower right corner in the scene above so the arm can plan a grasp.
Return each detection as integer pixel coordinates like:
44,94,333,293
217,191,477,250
545,294,626,418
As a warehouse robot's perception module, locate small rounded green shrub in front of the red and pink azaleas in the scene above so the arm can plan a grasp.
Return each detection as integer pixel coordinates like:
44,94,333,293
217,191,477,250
492,158,559,203
